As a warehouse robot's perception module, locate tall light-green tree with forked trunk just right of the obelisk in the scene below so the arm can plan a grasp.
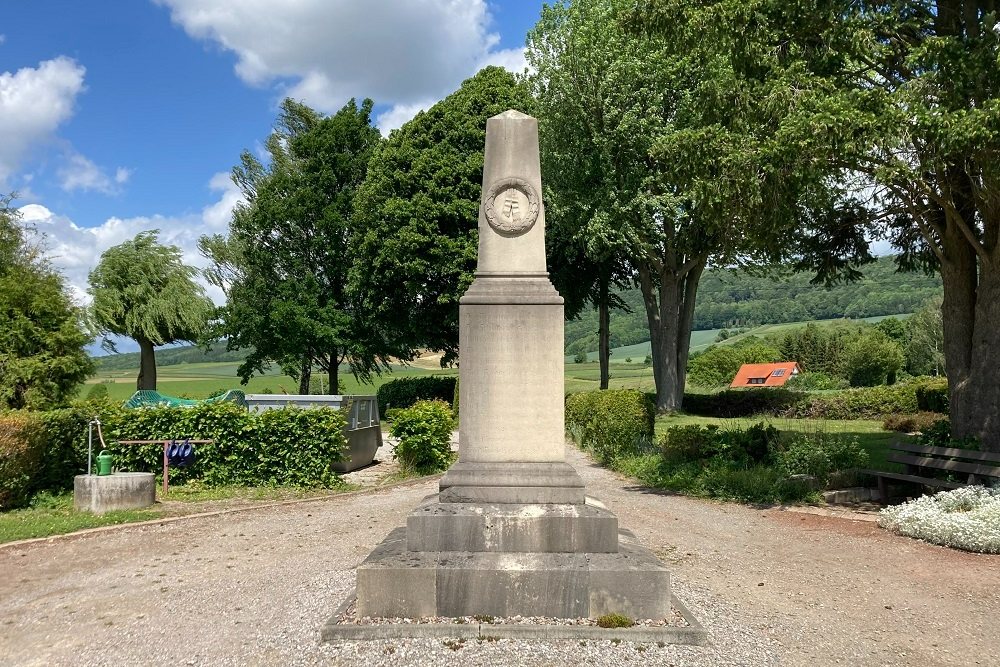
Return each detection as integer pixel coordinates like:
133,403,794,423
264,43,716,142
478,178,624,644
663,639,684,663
527,0,866,411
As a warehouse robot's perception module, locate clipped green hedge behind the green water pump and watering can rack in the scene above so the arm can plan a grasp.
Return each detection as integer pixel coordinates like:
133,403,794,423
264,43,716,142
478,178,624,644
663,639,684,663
0,402,347,509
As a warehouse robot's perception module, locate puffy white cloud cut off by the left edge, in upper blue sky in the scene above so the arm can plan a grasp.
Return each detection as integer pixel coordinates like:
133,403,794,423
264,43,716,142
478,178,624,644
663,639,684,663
0,57,86,185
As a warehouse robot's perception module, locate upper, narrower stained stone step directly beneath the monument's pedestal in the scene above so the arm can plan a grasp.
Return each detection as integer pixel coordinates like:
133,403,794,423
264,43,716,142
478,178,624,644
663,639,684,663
406,496,618,553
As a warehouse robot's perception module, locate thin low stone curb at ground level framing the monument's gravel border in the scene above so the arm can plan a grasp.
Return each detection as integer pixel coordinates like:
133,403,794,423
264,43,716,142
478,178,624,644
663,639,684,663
320,591,708,646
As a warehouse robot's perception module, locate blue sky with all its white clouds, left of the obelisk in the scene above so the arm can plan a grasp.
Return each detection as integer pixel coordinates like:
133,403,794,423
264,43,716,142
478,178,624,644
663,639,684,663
0,0,542,314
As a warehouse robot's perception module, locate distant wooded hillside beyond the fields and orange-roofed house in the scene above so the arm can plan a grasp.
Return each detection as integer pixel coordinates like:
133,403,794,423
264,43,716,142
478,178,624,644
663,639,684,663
565,257,941,354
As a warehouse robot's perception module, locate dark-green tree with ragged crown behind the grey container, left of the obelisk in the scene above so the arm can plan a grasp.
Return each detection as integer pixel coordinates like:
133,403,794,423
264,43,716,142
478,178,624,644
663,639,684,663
201,99,391,394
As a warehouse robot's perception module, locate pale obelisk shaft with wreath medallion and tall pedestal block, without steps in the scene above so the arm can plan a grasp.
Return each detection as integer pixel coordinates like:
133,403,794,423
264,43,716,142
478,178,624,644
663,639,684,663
456,110,582,468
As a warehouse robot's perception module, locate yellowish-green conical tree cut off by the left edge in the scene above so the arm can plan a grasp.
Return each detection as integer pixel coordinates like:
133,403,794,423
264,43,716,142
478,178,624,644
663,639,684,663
0,196,94,409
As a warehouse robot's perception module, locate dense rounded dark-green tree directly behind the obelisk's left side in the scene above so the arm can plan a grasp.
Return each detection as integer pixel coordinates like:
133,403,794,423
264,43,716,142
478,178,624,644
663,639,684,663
351,67,545,363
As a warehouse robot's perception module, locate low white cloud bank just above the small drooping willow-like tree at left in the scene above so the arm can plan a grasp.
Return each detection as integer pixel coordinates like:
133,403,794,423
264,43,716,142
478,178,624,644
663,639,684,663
20,174,240,304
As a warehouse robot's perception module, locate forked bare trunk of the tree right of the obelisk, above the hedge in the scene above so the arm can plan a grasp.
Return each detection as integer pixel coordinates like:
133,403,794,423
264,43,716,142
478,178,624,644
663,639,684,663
639,258,705,412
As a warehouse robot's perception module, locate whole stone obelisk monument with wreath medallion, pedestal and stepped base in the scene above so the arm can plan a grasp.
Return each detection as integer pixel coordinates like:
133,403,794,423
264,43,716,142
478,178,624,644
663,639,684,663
357,111,670,618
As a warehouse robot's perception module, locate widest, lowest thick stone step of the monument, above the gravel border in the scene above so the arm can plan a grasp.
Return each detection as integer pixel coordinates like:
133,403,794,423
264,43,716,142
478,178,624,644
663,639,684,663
357,528,670,618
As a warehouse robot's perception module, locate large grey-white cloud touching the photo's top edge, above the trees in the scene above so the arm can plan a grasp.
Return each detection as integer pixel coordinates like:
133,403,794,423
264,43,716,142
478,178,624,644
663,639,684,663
157,0,524,115
